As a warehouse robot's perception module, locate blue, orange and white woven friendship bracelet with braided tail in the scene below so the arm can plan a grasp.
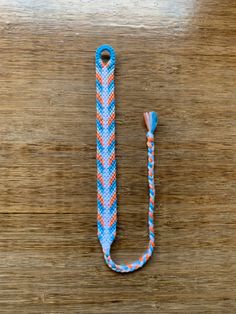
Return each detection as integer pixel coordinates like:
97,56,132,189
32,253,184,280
96,45,158,273
